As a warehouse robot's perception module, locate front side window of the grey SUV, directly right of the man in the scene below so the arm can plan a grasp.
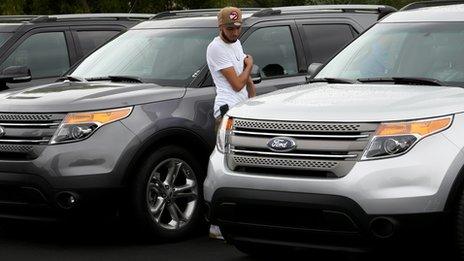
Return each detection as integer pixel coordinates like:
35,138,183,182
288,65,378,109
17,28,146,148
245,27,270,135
243,26,298,78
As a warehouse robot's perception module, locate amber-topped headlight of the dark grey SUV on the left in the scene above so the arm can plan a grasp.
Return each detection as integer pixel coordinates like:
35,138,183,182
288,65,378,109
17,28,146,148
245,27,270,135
50,107,132,144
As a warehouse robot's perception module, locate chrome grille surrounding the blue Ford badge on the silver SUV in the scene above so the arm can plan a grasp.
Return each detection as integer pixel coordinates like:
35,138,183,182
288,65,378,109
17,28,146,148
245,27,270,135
226,119,378,177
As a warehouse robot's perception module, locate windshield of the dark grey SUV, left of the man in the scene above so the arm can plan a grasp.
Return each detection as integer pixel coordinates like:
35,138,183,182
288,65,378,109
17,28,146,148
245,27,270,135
71,28,217,86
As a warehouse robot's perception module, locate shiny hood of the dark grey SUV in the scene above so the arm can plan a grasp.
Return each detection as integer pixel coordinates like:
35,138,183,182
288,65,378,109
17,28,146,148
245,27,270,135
0,81,185,112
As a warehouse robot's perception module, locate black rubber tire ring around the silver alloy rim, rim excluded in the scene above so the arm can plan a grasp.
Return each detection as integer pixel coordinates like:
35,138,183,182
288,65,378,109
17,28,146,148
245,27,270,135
129,146,204,241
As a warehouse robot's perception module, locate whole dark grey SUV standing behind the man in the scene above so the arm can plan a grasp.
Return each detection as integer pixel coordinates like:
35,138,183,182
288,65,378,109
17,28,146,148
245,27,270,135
0,6,393,238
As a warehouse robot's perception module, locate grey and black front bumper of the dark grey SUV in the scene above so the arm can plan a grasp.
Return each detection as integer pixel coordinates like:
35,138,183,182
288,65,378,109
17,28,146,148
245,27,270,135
0,122,139,220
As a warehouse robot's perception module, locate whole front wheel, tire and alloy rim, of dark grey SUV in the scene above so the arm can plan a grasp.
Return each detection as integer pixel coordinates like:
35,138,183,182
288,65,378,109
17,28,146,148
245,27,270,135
124,146,205,241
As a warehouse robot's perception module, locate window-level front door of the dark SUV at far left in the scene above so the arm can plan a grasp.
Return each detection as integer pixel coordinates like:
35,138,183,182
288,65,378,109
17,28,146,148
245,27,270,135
0,26,75,90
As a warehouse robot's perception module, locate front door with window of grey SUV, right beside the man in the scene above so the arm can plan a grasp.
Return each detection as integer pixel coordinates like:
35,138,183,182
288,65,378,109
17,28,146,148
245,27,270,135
241,20,307,95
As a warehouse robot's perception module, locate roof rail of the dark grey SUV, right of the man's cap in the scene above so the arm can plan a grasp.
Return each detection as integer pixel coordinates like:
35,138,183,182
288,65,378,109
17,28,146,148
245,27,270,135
252,5,396,19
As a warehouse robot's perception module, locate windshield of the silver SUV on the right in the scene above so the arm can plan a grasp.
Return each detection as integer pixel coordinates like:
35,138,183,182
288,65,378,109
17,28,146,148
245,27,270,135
315,23,464,86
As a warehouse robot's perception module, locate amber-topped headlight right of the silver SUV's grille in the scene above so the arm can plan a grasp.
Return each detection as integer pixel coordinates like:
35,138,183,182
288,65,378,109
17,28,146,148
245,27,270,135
362,116,453,160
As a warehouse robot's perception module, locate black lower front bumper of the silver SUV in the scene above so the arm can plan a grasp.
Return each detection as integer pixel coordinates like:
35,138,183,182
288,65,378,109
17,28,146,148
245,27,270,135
210,188,445,252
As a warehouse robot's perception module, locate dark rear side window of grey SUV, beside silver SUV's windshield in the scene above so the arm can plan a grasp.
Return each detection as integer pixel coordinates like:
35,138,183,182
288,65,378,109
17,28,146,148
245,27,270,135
303,24,354,63
